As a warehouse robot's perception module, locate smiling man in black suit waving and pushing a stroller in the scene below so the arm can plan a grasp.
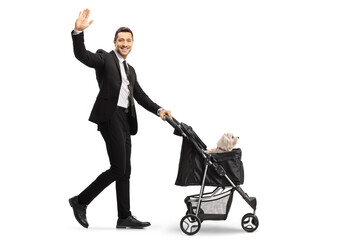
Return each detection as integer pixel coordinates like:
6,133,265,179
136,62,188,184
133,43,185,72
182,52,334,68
69,9,171,228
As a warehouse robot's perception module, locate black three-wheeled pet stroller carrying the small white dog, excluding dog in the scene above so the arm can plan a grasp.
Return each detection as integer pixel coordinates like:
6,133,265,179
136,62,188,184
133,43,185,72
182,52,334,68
165,116,259,235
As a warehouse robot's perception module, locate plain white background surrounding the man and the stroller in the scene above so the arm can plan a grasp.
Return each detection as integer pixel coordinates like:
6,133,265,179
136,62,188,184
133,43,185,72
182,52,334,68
0,0,360,239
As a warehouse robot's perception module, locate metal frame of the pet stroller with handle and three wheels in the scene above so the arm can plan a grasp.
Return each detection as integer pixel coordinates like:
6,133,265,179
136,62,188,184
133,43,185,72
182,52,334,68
165,115,259,235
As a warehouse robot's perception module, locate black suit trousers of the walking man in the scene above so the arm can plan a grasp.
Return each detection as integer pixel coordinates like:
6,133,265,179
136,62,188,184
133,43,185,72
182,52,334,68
78,107,131,219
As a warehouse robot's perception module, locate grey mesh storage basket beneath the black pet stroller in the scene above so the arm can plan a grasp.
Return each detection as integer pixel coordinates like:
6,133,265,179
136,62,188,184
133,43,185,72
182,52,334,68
185,189,234,220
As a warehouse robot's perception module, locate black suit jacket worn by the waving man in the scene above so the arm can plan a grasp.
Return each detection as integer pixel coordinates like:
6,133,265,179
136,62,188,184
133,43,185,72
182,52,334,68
71,32,160,135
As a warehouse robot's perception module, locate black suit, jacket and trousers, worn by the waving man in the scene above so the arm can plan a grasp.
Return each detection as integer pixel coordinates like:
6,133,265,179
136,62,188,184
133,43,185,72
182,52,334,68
72,33,160,218
